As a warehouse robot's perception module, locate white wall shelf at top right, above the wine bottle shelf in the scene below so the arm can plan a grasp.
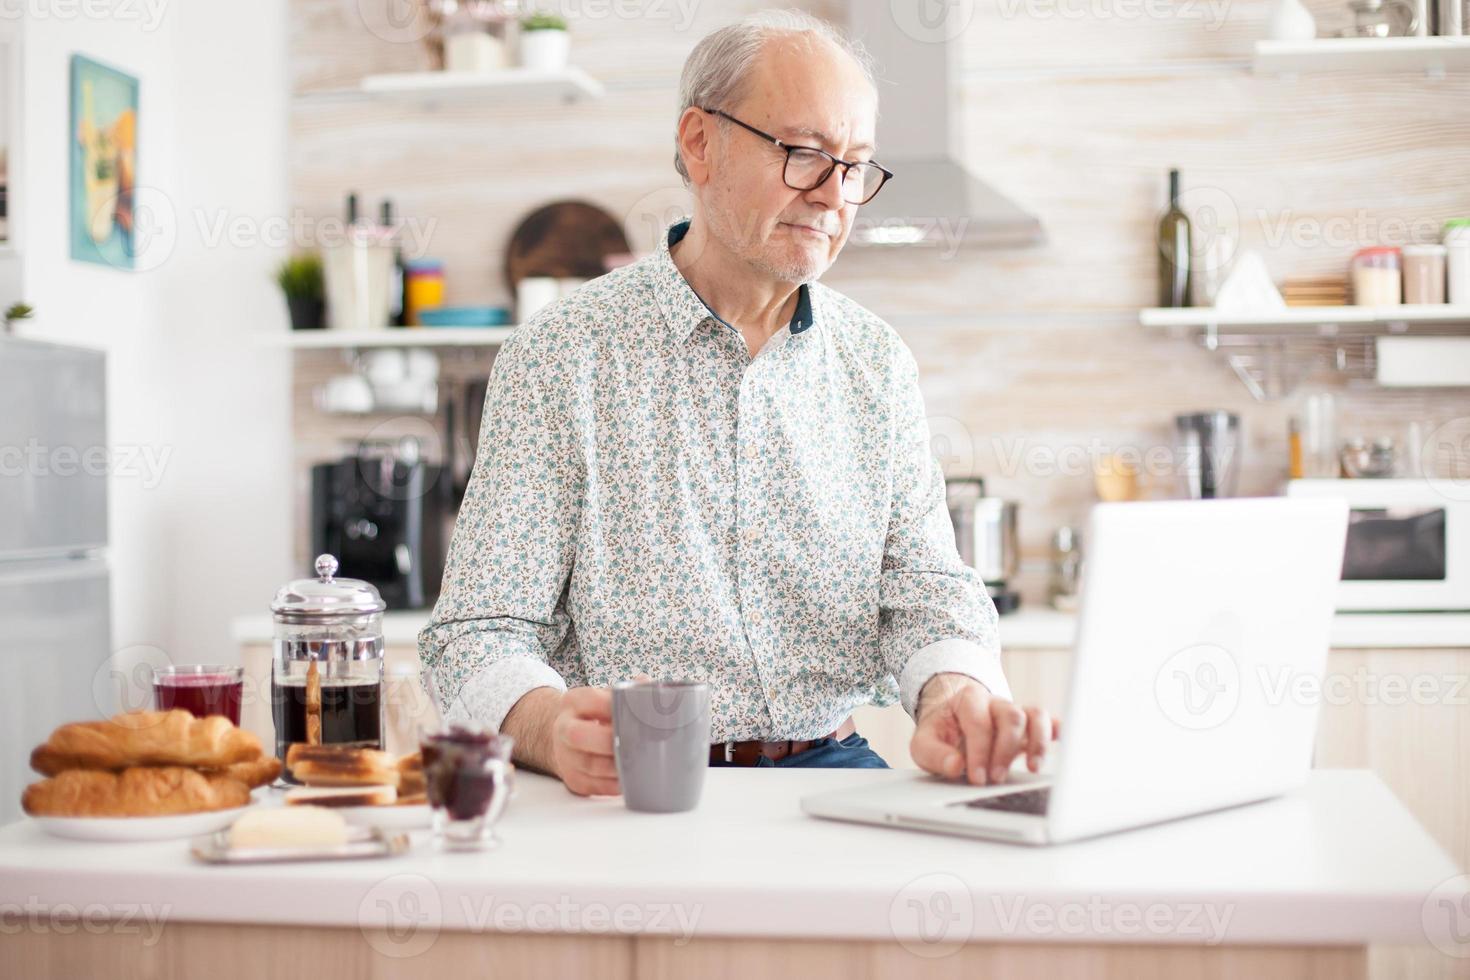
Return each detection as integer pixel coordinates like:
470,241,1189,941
1254,37,1470,75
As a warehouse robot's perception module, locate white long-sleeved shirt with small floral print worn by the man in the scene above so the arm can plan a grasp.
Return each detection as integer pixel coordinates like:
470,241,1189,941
419,219,1010,742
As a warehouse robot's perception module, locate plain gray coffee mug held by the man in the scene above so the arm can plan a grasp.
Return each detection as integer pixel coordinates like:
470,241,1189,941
613,680,710,813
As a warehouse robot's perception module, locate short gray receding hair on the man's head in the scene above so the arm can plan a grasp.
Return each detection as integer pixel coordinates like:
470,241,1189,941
673,10,878,187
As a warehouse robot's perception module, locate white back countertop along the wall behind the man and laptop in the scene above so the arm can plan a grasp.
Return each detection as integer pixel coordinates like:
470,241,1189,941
231,605,1470,649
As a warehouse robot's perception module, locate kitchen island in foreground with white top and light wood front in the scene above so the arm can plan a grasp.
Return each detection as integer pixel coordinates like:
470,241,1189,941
0,768,1470,980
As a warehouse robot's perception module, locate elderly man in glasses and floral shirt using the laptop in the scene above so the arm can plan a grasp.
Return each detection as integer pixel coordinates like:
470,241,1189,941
419,13,1054,795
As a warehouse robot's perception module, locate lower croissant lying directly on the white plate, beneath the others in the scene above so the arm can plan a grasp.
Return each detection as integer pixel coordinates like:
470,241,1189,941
21,765,250,817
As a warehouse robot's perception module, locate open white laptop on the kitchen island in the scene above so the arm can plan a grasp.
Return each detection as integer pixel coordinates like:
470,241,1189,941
801,498,1348,843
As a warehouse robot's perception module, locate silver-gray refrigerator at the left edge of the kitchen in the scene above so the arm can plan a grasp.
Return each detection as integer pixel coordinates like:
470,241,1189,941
0,336,112,823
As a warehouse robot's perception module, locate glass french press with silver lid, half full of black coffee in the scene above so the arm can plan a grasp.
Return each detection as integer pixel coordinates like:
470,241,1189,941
270,555,387,761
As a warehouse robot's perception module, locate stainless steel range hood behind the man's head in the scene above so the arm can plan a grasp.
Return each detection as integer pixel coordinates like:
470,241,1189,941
847,0,1045,248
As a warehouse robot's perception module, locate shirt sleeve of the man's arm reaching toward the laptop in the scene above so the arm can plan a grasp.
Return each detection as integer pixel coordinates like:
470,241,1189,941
878,348,1011,716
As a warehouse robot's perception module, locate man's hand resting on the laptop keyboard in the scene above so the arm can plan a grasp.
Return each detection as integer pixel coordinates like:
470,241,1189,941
908,674,1060,786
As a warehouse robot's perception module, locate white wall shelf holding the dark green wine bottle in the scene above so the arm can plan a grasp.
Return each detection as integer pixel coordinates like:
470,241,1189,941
1138,303,1470,335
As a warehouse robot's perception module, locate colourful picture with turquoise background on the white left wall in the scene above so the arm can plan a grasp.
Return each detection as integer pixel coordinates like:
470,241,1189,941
68,54,138,269
